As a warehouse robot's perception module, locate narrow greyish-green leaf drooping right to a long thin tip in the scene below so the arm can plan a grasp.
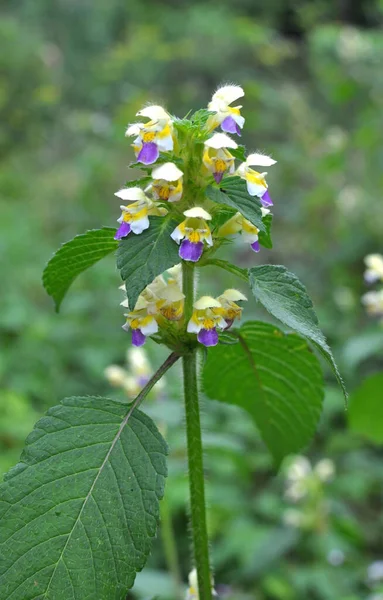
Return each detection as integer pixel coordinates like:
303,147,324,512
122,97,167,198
249,265,347,400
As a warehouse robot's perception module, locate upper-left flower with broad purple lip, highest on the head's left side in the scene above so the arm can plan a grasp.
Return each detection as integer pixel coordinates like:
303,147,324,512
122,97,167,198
125,106,174,165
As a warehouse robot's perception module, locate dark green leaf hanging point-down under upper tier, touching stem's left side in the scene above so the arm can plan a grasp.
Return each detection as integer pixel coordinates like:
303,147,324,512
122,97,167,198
117,217,181,308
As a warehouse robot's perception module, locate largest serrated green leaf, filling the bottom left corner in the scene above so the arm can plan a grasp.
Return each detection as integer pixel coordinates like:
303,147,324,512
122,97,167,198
0,397,167,600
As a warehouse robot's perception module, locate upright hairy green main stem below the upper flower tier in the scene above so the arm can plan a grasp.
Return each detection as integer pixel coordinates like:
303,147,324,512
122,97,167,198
182,264,212,600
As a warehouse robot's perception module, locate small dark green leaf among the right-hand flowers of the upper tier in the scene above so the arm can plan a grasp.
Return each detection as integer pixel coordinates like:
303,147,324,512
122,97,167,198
206,176,266,231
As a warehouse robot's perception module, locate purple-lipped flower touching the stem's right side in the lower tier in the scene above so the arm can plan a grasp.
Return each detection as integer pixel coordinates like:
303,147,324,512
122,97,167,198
187,296,227,346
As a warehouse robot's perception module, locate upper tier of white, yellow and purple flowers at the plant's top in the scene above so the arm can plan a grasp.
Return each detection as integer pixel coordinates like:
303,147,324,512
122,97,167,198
115,85,276,254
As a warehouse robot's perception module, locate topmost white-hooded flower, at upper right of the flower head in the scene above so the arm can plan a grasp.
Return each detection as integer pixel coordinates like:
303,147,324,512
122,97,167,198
207,85,245,136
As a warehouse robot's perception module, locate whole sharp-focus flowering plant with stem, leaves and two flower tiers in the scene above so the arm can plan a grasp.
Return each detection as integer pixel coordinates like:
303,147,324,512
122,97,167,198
0,85,344,600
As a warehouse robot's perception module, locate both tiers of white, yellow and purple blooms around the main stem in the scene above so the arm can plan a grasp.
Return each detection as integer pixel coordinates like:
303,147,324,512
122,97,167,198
115,85,276,346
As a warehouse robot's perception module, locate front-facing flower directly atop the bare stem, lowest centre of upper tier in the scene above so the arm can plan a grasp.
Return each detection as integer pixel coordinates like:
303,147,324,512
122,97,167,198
171,206,213,262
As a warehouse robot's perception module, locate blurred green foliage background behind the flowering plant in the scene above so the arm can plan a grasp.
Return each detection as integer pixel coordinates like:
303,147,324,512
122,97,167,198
0,0,383,600
